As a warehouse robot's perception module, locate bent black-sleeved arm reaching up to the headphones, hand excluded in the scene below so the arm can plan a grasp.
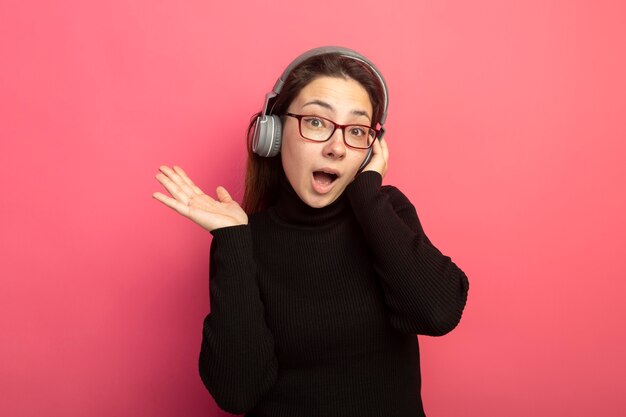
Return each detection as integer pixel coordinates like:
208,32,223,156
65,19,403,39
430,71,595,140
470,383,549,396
347,171,469,336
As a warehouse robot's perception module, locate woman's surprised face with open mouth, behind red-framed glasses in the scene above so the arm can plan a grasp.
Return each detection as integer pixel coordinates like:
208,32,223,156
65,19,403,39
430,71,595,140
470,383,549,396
280,76,372,208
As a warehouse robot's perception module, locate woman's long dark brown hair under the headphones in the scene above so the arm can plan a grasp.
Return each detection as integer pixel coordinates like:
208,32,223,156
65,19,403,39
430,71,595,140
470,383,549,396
242,53,385,214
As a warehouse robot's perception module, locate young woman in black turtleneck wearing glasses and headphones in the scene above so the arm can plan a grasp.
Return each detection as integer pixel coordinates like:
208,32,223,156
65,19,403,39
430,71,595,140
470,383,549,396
154,47,469,417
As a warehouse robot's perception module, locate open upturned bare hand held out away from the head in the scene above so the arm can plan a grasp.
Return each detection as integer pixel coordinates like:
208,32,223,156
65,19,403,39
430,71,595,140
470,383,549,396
152,166,248,232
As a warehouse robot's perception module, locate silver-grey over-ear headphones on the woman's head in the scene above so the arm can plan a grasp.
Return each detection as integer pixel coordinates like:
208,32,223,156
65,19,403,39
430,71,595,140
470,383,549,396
252,46,389,170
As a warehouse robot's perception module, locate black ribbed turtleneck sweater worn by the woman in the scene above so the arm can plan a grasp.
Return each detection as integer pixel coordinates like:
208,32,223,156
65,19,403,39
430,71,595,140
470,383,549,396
199,172,469,417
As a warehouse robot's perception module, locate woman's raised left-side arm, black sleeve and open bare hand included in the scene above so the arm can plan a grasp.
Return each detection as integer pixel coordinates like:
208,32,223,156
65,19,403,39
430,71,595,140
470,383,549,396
153,166,278,414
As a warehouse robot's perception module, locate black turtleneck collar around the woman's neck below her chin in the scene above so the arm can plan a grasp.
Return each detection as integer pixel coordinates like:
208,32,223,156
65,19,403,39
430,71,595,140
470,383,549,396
272,174,349,227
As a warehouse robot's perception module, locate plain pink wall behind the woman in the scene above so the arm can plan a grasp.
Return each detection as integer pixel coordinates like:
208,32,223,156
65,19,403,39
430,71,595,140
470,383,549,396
0,0,626,417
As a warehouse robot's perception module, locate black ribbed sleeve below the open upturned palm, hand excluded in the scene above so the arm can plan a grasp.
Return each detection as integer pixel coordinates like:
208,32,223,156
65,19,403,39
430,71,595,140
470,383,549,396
199,226,278,414
